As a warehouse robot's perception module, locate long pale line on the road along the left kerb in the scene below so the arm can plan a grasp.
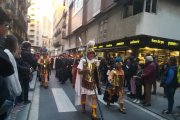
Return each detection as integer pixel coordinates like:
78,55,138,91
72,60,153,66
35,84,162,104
28,80,40,120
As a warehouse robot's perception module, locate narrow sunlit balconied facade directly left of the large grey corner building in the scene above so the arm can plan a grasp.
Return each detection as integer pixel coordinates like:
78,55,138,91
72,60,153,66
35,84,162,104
52,0,67,56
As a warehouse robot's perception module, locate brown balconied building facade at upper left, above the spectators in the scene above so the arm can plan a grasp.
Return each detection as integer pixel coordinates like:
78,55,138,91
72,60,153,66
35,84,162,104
0,0,31,43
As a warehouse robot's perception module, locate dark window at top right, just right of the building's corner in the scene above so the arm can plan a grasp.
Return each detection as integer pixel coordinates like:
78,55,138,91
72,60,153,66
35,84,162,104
146,0,157,13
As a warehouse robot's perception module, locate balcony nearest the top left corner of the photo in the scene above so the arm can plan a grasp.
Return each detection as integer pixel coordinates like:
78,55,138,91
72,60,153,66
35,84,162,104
5,0,15,16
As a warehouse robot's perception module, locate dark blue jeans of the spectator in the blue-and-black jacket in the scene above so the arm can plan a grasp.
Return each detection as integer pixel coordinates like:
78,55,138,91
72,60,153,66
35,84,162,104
165,88,176,112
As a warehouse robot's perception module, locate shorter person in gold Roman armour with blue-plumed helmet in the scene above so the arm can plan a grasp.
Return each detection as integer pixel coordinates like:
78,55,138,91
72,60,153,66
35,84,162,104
103,61,126,114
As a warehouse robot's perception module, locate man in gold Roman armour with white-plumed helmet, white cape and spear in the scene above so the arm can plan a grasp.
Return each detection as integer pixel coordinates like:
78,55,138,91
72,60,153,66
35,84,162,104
75,41,101,120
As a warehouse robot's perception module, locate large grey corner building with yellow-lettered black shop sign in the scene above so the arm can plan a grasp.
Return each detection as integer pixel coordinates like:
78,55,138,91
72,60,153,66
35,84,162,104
65,0,180,64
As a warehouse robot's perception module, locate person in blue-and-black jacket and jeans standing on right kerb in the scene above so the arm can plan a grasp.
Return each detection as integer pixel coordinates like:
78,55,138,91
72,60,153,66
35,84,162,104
163,57,178,114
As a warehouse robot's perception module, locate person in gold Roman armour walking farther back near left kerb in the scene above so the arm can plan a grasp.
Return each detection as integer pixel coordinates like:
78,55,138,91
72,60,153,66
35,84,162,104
38,49,51,88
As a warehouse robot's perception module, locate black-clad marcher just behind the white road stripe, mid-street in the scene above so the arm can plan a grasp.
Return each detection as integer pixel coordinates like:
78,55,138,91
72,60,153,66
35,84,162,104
57,53,68,84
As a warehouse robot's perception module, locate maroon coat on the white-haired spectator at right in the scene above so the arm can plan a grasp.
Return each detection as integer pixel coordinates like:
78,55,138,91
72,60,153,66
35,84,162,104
142,62,156,84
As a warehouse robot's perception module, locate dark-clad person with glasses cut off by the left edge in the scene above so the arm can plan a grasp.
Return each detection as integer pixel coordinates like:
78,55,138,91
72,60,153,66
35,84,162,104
0,7,14,120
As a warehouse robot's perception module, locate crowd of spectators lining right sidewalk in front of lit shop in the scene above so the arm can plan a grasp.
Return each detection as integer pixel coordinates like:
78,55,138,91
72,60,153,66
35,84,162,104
99,53,179,114
